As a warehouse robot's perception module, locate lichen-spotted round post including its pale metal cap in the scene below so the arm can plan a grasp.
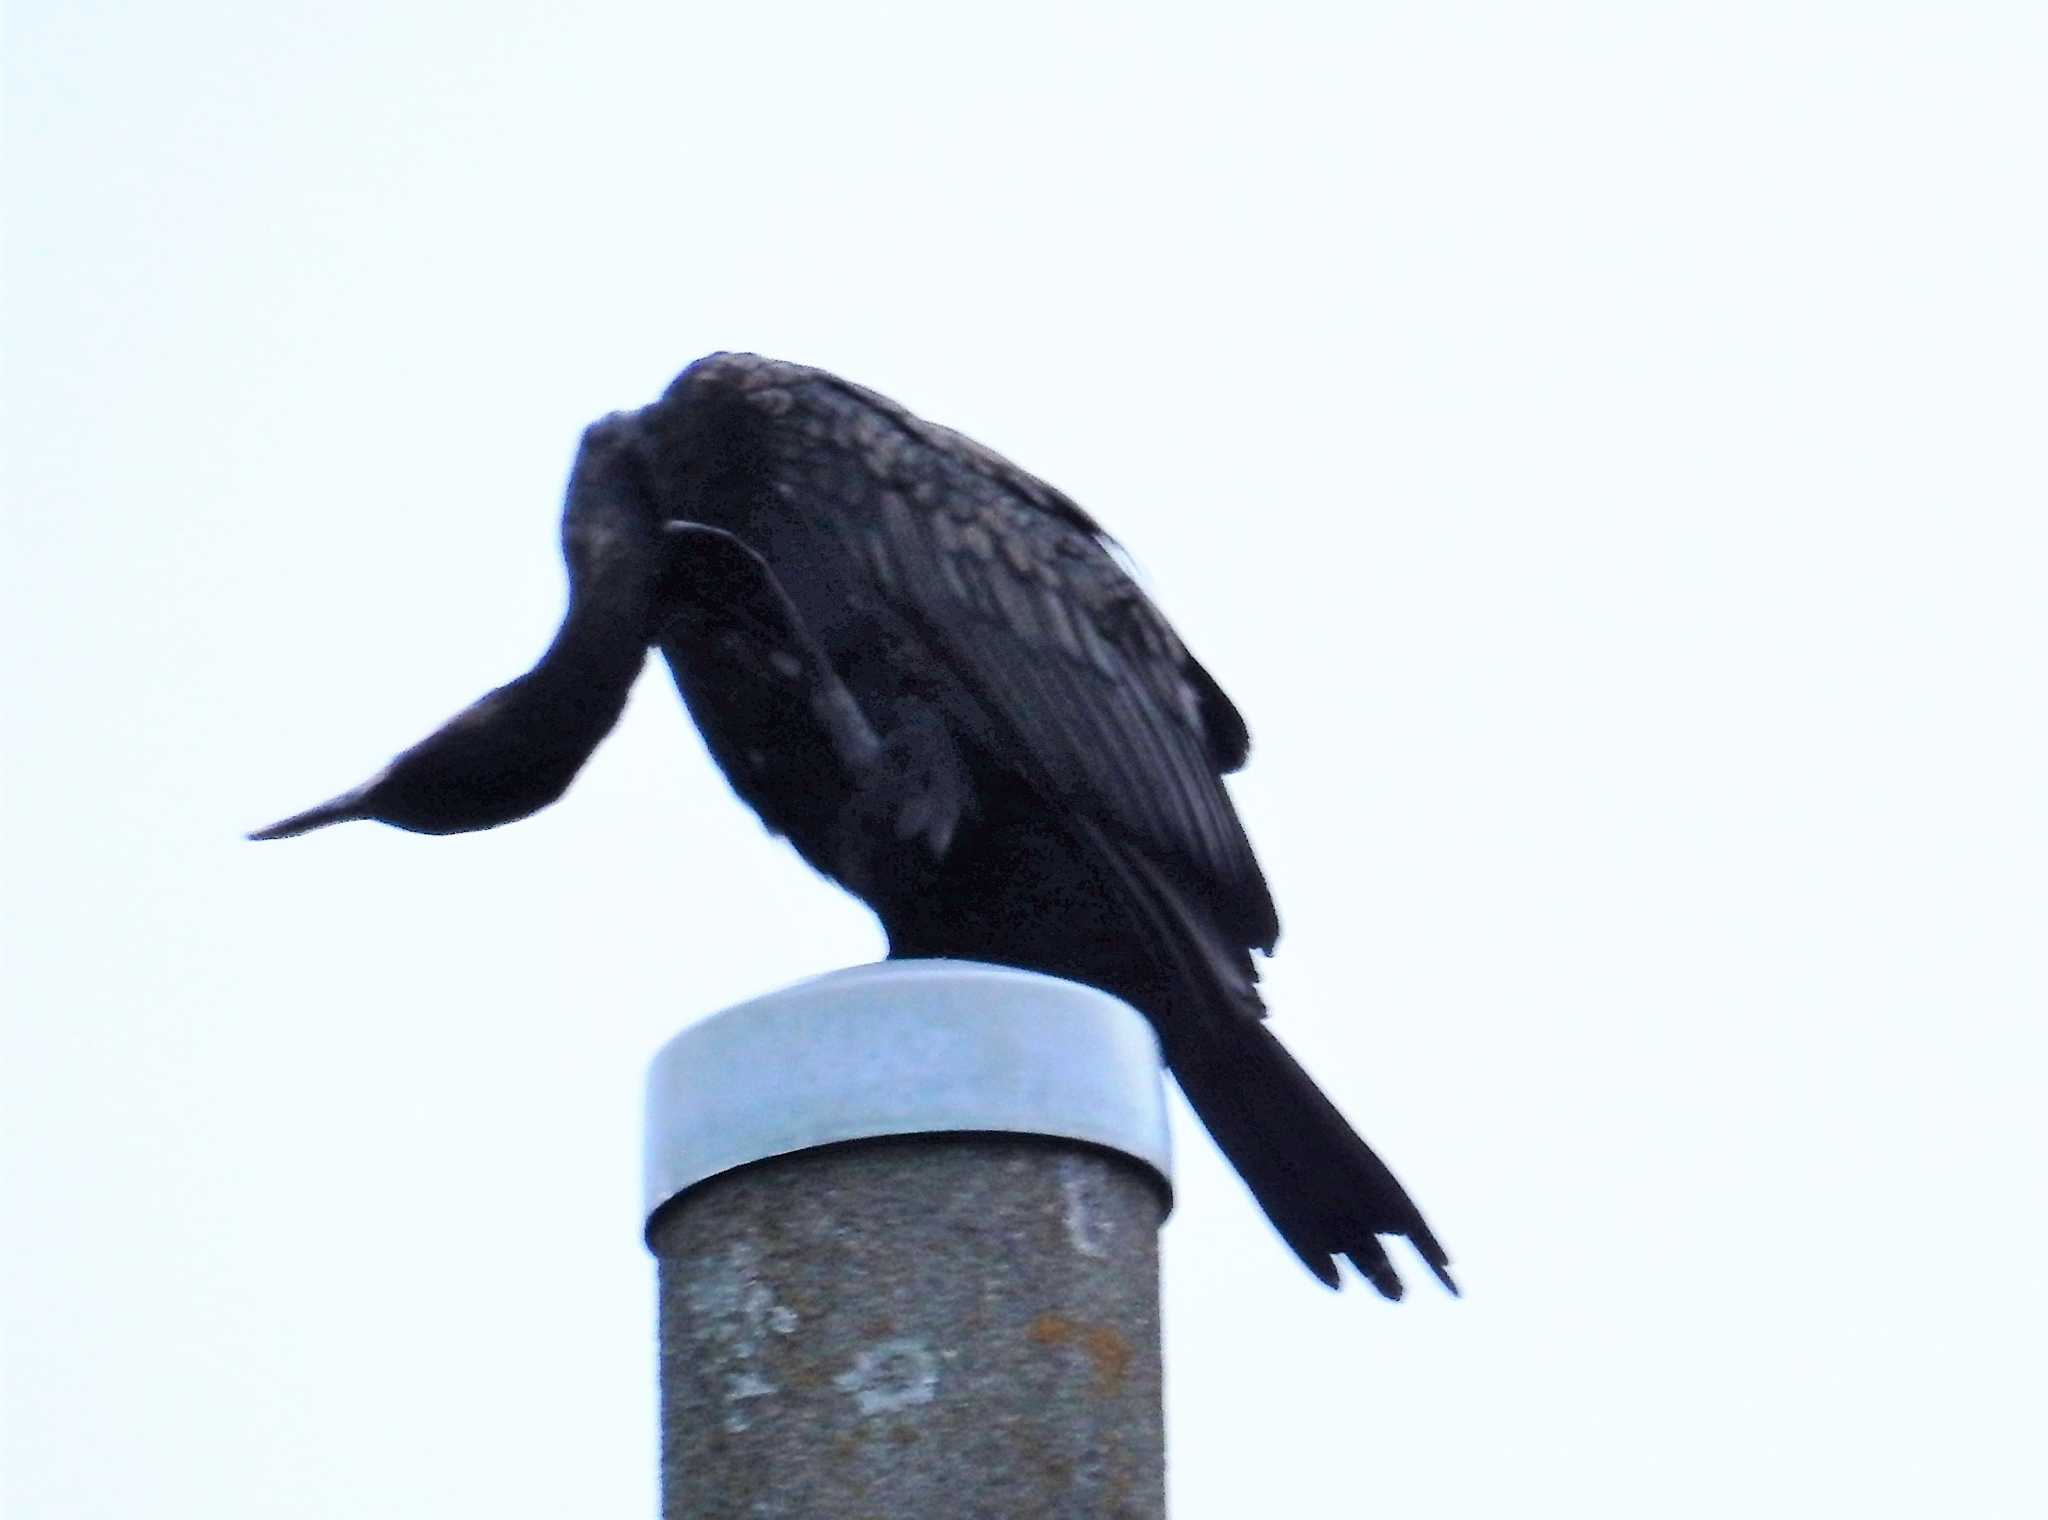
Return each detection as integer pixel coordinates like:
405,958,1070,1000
647,961,1171,1520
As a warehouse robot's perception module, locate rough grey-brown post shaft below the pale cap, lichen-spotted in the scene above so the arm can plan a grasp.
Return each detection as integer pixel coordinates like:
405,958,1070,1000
649,1135,1165,1520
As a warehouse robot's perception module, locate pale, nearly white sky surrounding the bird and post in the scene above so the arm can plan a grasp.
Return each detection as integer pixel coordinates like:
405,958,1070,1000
4,0,2048,1520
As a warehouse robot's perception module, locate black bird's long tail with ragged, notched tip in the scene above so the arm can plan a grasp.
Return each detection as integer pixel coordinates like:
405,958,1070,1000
1085,830,1458,1299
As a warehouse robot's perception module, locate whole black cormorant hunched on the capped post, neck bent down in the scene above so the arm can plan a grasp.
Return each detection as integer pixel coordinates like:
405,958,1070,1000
250,352,1458,1299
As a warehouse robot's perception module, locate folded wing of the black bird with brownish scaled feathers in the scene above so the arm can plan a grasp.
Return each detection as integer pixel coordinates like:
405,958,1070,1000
655,354,1278,948
